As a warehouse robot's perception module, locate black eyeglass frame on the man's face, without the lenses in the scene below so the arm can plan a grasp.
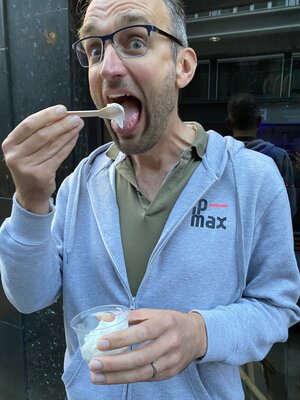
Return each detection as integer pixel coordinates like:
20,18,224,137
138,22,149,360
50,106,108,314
72,24,184,68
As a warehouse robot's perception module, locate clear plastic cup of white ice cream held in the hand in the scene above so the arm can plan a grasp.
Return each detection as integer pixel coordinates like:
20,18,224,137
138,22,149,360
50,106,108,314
71,305,129,362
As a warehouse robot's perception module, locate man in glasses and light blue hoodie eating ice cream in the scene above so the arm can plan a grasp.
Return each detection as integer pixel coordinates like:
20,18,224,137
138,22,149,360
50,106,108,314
0,0,299,400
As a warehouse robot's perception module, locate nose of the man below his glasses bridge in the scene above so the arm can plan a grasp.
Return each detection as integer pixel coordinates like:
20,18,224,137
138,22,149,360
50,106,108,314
100,43,127,80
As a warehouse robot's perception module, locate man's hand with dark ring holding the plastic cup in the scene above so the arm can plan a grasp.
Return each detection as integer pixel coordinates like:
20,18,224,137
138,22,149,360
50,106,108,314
89,309,207,384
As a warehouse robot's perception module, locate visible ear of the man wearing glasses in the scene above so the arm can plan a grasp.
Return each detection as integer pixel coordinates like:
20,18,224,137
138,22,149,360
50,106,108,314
176,47,197,89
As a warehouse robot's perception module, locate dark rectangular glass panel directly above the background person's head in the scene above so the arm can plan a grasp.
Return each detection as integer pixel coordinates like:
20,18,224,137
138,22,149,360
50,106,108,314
217,56,283,99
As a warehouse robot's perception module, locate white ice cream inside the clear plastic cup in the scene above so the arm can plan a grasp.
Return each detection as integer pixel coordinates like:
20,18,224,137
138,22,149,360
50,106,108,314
81,313,128,362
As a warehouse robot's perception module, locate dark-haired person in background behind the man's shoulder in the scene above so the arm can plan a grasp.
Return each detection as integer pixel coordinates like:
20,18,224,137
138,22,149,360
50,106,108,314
227,93,297,217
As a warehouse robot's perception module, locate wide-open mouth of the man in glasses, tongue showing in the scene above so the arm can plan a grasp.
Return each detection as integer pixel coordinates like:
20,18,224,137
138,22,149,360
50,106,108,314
108,94,142,133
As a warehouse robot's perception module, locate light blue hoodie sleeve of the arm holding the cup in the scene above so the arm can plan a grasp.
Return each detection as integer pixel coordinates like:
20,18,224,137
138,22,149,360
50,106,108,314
194,177,300,365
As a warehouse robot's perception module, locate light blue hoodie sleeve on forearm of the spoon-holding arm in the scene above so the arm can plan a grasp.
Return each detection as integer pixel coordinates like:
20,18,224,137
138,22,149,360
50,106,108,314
0,196,61,313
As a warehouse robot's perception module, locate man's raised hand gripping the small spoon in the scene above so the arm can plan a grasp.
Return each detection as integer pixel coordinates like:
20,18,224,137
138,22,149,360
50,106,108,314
2,105,83,214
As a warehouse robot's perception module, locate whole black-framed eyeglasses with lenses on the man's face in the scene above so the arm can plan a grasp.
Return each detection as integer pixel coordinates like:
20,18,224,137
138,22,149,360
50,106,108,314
72,25,183,68
